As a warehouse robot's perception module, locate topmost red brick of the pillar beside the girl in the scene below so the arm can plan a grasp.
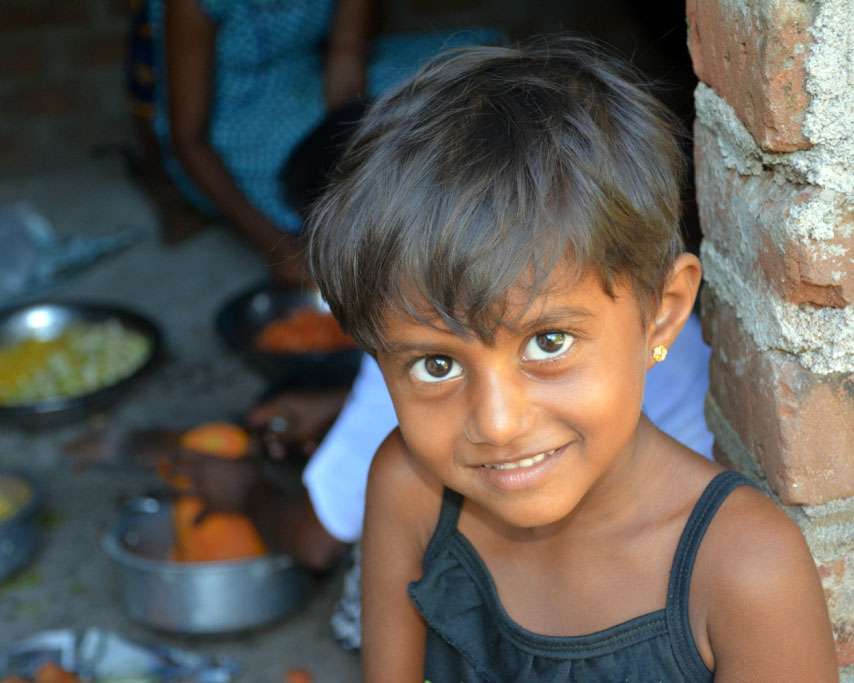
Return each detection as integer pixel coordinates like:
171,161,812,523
686,0,814,152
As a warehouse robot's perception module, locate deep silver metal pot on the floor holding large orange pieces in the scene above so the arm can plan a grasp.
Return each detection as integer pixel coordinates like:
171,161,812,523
103,498,310,635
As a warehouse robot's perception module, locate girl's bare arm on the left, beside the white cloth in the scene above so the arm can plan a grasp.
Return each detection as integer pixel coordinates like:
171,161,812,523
362,430,441,683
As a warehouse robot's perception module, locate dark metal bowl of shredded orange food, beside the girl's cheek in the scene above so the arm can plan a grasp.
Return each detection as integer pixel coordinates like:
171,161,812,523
214,282,362,389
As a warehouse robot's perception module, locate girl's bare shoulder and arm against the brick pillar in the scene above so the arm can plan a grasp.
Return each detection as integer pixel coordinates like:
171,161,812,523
698,489,839,683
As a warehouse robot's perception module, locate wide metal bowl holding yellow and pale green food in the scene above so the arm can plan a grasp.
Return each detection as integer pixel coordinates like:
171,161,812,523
0,301,163,429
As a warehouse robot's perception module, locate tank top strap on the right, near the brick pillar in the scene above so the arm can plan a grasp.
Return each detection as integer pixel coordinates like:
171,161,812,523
666,471,756,680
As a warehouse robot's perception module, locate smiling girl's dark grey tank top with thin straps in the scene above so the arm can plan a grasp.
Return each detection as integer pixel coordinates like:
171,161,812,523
409,472,752,683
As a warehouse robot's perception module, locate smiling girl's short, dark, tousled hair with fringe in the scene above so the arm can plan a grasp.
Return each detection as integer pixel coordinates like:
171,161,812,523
308,37,684,351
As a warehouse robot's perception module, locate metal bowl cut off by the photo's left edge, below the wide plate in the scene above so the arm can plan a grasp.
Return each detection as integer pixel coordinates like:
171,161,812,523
0,470,42,581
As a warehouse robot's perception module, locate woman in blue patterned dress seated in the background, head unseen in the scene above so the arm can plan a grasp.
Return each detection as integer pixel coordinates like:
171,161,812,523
143,0,498,281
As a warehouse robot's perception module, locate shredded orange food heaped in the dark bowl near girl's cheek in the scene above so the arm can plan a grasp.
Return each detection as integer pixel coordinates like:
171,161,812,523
255,306,356,353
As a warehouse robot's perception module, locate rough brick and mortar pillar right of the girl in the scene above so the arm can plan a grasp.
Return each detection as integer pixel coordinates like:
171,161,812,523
687,0,854,681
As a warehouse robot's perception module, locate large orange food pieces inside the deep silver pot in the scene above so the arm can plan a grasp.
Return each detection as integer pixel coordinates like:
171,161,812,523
172,496,267,562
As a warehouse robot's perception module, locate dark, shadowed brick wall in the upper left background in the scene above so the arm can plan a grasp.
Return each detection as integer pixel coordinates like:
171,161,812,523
0,0,129,173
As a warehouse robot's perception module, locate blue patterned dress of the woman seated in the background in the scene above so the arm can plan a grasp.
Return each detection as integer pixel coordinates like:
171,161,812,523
148,0,499,232
